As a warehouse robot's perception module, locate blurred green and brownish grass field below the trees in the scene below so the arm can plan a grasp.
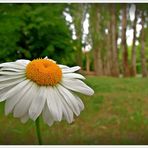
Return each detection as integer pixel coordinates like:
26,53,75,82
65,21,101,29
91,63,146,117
0,77,148,145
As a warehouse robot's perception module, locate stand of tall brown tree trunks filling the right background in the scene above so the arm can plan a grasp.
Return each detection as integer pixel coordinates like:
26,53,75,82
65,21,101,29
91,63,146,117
68,3,148,77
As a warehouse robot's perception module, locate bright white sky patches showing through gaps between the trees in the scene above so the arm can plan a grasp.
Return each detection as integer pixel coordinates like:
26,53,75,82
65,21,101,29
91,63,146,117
64,4,142,51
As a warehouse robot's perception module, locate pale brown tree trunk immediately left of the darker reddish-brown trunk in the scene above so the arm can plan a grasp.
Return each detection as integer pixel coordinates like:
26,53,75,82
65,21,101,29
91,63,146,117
111,4,119,77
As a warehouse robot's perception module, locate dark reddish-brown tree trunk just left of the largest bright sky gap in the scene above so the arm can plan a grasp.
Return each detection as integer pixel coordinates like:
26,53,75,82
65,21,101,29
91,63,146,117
122,4,130,77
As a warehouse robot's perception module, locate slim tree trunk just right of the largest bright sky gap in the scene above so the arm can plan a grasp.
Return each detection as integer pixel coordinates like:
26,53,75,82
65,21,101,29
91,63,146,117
131,8,137,76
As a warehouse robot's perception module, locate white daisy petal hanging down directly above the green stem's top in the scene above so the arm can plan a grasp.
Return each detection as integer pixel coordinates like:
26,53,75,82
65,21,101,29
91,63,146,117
29,86,47,121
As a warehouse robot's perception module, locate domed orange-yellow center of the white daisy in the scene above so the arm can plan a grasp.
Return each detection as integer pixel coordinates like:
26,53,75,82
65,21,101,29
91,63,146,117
26,59,62,86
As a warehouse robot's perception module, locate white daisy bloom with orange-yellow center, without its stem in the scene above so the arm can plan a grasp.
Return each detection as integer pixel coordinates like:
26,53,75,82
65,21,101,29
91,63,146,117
0,57,94,126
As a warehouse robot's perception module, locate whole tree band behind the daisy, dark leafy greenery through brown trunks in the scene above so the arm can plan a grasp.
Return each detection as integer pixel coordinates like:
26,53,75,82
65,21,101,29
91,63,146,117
0,3,148,77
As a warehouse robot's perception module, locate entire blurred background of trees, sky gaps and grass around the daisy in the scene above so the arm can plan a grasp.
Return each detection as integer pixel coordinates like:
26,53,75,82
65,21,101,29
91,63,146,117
0,3,148,144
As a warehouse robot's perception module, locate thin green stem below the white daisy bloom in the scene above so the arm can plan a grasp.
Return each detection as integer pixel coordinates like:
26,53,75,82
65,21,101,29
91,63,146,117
35,117,42,145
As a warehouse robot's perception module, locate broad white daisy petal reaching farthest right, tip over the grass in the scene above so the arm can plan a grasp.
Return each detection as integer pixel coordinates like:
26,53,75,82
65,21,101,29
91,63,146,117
61,79,94,95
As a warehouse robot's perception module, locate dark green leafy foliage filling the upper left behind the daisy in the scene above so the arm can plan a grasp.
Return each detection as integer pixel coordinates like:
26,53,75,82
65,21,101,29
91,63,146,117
0,4,74,64
